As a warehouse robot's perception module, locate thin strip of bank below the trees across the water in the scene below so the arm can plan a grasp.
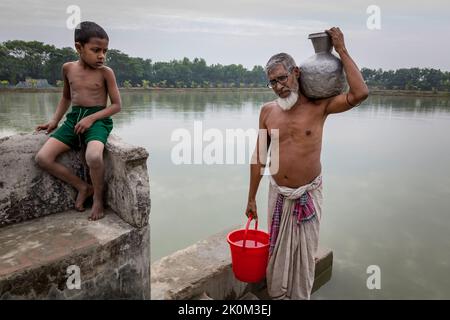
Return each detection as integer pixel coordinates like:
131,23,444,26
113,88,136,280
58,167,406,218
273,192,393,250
0,87,450,97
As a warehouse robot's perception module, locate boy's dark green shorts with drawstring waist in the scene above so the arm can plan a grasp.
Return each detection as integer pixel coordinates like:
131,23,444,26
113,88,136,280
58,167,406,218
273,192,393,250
50,106,113,149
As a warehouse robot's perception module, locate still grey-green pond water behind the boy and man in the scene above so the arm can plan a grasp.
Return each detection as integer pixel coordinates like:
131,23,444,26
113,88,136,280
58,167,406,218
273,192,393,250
0,91,450,299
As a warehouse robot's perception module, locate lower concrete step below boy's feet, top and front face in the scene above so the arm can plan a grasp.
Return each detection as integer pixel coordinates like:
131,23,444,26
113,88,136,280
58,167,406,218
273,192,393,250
0,210,150,299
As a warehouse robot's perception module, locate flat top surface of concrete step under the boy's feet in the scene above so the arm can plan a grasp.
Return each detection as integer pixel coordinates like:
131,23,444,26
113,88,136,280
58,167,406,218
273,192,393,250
0,210,133,280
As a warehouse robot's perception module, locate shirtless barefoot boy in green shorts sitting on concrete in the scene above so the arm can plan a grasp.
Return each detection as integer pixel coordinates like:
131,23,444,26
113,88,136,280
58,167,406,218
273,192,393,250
36,21,121,220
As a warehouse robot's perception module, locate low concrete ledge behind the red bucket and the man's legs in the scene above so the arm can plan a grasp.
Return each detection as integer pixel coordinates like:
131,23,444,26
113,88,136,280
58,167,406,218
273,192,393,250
151,226,333,300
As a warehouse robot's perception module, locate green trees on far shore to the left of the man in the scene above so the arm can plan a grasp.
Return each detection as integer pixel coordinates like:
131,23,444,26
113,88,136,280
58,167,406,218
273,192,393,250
0,40,266,88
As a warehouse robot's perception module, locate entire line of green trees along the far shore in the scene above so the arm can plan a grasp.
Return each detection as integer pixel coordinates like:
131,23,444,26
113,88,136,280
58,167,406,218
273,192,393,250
0,40,450,91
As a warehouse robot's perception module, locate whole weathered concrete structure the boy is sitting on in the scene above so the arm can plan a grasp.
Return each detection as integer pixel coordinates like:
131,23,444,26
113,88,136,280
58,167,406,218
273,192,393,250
0,133,150,299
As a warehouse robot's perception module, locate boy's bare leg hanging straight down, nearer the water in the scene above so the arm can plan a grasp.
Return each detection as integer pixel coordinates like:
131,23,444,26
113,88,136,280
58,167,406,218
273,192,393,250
86,140,105,220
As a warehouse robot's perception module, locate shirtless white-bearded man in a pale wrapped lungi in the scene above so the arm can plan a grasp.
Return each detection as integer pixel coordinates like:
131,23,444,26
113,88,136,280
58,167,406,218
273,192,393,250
246,28,368,299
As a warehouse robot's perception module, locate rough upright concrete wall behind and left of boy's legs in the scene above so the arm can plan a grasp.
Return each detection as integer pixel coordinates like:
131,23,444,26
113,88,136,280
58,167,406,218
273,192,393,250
0,134,86,227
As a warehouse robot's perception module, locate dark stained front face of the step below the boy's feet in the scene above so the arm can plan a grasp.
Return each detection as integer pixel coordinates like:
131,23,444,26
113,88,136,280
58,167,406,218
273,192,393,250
0,226,151,300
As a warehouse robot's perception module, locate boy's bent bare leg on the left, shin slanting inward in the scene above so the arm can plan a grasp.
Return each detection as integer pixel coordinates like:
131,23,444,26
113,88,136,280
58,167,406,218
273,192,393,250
35,138,94,211
